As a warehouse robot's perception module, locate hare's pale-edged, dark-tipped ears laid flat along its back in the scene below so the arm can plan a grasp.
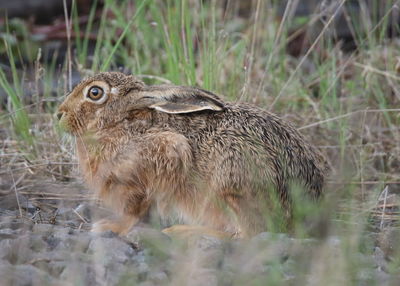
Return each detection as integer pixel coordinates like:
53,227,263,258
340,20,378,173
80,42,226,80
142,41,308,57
144,86,224,114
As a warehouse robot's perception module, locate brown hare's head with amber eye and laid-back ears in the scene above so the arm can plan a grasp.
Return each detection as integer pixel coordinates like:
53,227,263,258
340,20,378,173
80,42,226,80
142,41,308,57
57,72,224,134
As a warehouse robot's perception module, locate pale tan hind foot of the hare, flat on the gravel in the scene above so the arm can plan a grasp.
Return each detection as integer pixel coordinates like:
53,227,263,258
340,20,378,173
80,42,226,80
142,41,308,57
162,224,236,239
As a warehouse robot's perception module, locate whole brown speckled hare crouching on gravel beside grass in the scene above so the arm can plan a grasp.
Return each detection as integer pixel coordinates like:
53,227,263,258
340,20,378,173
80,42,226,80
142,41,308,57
57,72,326,237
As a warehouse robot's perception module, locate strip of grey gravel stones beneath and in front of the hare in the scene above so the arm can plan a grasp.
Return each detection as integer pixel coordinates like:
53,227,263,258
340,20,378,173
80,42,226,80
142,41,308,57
0,200,397,286
